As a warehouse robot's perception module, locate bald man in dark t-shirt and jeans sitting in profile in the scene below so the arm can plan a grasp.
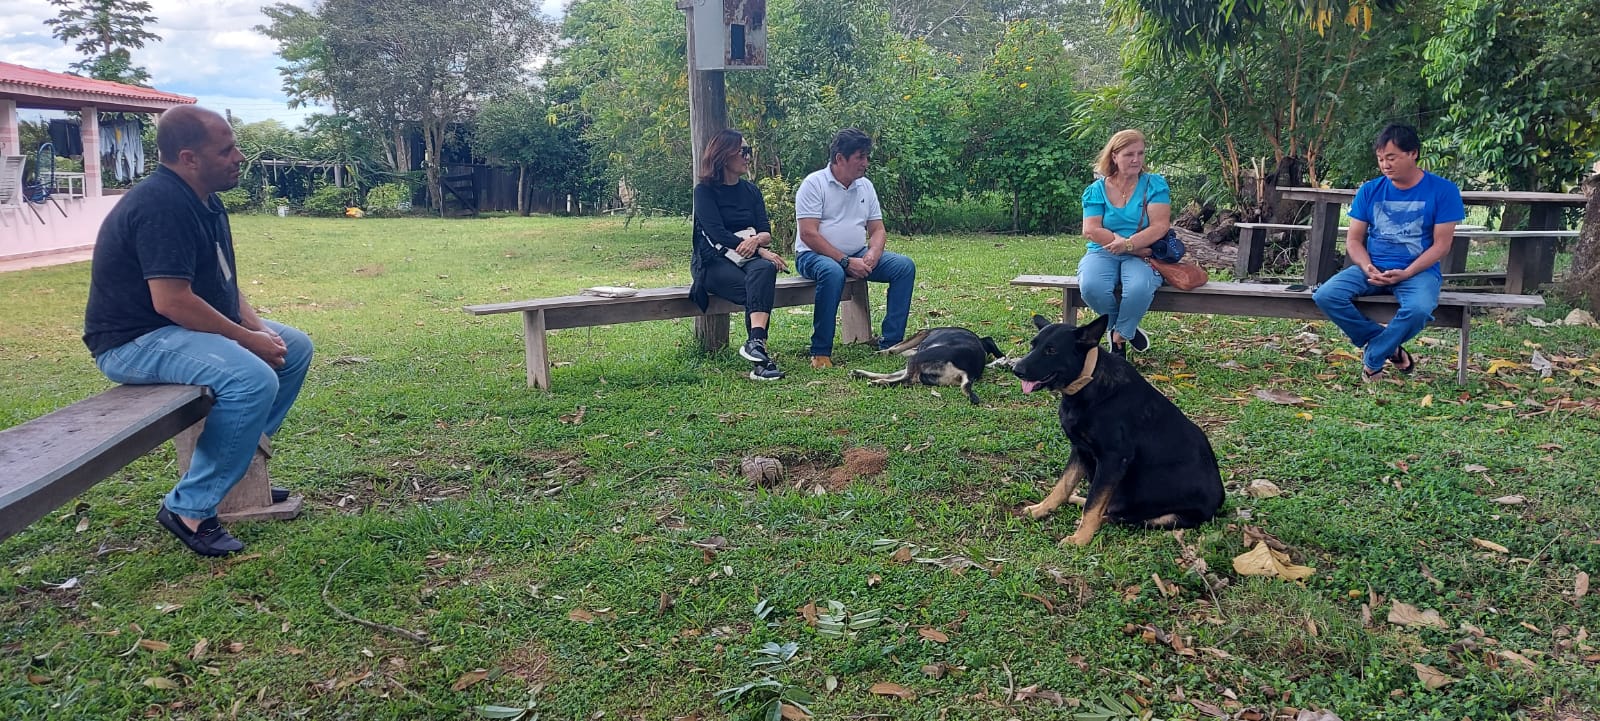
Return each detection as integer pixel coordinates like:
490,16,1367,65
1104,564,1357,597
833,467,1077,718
83,106,312,556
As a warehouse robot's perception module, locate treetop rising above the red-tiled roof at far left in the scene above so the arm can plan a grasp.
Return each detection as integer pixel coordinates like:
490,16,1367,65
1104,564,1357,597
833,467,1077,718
45,0,162,85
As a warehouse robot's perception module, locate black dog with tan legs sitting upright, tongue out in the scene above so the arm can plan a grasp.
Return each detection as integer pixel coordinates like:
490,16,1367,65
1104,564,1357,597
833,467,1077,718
1011,315,1222,545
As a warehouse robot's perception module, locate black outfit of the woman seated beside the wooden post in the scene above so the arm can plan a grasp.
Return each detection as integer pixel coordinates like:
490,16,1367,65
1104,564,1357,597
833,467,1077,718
690,179,778,321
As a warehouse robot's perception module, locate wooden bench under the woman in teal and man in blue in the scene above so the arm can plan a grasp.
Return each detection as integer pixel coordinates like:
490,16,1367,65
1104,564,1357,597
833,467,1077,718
1011,275,1544,385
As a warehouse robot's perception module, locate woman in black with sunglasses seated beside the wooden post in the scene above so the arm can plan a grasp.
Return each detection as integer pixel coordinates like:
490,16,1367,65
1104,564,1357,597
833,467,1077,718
690,129,789,380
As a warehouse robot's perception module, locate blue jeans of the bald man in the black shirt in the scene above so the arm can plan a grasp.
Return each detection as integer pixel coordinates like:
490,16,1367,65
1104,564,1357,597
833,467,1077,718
94,320,310,520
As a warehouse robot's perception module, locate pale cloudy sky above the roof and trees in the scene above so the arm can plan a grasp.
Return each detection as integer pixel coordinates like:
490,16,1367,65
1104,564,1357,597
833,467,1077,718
0,0,563,128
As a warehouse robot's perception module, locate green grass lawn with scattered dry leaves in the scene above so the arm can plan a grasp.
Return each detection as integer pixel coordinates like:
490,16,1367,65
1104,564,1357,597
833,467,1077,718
0,216,1600,721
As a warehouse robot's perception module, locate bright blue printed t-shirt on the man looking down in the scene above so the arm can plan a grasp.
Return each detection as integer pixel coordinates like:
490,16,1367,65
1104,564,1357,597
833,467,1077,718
1350,171,1467,275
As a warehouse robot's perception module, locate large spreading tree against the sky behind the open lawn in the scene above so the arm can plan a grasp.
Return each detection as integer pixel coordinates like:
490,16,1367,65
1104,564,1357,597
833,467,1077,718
252,0,549,208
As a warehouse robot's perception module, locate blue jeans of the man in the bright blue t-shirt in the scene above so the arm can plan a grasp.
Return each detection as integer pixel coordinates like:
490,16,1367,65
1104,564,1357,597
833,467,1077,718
1312,265,1443,372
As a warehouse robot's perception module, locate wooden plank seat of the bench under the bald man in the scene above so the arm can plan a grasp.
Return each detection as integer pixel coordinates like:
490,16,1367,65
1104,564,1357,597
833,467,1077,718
0,385,213,540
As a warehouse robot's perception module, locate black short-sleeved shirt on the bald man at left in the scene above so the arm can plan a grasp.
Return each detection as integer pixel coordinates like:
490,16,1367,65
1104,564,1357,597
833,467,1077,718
83,165,240,358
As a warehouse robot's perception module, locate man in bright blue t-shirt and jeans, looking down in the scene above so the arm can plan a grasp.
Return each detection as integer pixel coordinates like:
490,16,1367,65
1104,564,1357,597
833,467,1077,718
1314,125,1467,382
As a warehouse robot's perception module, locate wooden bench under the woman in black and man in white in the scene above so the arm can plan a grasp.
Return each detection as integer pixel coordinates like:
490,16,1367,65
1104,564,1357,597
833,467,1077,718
462,277,872,390
